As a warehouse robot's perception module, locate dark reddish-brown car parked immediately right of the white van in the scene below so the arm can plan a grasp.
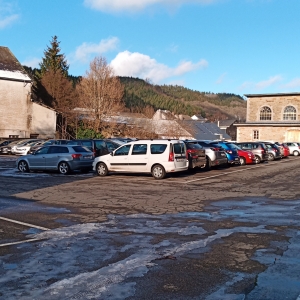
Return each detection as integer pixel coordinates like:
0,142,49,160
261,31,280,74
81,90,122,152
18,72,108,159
183,140,206,170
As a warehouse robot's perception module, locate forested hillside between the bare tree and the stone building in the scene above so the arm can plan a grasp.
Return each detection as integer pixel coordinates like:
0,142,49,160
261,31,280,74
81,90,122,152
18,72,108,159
119,77,246,121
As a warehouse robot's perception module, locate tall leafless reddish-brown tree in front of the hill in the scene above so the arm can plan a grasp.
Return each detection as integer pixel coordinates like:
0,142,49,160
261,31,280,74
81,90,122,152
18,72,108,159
77,56,124,132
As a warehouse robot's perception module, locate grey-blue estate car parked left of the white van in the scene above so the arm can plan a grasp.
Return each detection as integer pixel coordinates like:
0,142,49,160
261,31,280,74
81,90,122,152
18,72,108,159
16,145,94,175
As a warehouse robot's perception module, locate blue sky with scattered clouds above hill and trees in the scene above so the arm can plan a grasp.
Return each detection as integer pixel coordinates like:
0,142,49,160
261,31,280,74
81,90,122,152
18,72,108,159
0,0,300,95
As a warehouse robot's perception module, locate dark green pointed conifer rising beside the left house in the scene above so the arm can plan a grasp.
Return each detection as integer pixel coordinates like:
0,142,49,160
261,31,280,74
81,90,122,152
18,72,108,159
40,35,69,77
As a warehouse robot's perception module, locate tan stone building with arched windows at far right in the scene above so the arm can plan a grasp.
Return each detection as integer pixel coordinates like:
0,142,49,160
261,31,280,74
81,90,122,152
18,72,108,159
234,93,300,142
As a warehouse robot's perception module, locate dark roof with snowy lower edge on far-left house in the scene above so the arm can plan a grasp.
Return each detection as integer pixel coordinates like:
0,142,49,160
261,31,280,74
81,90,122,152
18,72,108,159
0,46,32,82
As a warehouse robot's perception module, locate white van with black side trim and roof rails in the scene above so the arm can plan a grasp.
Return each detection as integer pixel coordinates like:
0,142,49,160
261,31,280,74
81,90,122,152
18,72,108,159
93,139,188,179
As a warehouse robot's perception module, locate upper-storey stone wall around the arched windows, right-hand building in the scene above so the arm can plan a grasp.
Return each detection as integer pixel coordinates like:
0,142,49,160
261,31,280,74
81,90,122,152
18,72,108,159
246,95,300,122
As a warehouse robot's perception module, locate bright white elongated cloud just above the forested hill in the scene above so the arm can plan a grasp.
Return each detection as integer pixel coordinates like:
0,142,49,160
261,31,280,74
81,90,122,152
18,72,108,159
111,51,208,83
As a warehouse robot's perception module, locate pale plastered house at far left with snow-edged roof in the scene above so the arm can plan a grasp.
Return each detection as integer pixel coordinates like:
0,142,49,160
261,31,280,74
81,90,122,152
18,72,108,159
0,46,56,138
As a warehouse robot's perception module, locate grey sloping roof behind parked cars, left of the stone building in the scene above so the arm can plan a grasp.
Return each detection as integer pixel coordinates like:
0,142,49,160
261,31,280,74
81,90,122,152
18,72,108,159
183,121,231,140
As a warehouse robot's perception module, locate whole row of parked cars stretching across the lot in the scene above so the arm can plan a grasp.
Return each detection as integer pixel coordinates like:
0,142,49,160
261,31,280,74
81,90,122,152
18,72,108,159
0,138,300,179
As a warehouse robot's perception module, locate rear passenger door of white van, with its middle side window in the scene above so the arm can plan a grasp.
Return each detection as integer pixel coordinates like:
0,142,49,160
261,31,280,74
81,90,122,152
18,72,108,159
128,143,149,172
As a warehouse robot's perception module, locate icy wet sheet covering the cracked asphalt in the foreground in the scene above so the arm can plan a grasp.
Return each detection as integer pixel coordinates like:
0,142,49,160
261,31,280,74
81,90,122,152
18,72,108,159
0,198,300,300
